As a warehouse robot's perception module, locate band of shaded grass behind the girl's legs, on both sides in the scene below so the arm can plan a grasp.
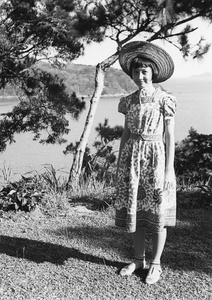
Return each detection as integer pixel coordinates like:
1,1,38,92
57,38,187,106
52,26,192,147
49,209,212,274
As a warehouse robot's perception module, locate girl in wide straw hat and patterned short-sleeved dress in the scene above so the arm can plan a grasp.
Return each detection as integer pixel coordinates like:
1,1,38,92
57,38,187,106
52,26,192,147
115,41,176,284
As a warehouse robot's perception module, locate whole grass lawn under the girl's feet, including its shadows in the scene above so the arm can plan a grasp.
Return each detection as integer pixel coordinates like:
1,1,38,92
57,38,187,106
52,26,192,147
0,201,212,300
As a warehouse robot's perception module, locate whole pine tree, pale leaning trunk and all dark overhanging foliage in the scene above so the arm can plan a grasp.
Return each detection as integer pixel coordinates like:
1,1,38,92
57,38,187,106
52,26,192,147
0,0,212,184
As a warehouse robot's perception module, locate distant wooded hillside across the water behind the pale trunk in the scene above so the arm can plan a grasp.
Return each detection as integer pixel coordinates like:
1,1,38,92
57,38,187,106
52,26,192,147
0,63,136,96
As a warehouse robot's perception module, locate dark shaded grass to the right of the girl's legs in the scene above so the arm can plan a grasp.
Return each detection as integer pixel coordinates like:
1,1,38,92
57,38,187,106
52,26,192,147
163,208,212,275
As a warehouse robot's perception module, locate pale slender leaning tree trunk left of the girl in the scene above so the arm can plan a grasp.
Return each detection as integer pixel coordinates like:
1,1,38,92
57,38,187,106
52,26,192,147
68,52,118,186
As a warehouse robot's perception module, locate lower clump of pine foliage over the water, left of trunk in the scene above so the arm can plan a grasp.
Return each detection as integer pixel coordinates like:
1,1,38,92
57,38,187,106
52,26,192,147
0,73,85,151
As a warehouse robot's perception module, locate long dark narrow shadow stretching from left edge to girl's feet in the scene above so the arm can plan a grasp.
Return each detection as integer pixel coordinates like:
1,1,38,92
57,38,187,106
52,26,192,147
0,235,123,269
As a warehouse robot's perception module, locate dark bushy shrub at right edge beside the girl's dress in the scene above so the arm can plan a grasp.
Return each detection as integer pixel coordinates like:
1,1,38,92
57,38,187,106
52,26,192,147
175,128,212,208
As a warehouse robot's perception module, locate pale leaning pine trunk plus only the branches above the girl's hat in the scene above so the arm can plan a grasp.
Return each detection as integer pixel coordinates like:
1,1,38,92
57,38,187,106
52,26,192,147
69,0,212,184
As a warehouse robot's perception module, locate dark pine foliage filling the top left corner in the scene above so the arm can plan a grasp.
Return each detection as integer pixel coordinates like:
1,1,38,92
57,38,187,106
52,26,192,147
0,0,78,87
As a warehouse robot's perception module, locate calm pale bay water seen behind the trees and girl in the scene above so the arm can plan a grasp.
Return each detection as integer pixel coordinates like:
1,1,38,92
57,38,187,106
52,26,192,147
0,77,212,180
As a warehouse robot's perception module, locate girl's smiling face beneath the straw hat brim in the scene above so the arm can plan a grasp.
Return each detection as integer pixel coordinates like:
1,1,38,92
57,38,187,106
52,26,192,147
132,67,153,89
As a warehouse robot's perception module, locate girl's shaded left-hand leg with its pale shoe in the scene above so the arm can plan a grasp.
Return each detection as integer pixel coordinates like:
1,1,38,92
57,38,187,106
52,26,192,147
120,228,146,276
